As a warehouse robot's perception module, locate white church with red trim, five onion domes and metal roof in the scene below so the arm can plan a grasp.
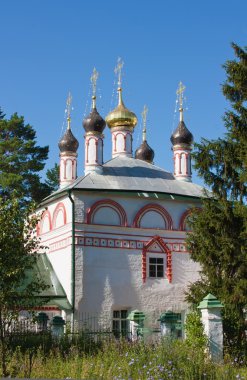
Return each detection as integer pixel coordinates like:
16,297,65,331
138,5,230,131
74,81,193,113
37,66,203,332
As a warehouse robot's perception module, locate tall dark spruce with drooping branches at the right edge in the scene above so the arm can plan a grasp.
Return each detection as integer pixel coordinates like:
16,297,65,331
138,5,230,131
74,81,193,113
187,44,247,354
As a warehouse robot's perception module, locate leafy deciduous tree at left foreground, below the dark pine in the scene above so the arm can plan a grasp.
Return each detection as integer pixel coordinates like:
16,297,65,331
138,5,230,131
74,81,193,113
0,196,46,376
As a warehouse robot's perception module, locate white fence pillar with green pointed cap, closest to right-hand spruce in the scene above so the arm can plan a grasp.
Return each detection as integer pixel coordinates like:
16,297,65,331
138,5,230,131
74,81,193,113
197,293,223,362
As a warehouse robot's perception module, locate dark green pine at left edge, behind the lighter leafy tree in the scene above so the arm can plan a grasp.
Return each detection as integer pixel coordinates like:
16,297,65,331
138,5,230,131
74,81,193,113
0,110,51,202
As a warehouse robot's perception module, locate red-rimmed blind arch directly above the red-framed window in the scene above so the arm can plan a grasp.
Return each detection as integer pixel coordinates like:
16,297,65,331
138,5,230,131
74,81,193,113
133,204,172,230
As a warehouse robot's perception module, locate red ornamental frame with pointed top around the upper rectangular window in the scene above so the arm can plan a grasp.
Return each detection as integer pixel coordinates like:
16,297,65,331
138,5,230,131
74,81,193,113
142,236,172,283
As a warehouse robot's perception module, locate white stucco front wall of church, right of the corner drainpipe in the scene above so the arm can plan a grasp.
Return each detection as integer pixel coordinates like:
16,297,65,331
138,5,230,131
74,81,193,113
75,193,199,317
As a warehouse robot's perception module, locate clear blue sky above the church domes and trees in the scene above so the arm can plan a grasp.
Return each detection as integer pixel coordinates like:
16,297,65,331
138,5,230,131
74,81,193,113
0,0,247,182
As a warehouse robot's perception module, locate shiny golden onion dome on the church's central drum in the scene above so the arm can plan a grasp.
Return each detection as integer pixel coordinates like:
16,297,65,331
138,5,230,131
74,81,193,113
105,87,137,128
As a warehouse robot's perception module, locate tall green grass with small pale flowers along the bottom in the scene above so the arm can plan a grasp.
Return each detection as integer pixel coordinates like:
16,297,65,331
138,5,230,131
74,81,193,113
2,340,247,380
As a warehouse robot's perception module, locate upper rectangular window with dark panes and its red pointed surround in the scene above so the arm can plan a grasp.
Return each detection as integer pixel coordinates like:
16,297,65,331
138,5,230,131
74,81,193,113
142,236,172,283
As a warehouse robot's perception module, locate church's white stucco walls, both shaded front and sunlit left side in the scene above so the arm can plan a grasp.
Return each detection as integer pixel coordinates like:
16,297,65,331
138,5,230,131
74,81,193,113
37,191,199,318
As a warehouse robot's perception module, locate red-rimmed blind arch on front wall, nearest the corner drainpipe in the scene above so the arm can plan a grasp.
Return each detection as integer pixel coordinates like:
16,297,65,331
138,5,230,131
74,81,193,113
87,199,127,226
